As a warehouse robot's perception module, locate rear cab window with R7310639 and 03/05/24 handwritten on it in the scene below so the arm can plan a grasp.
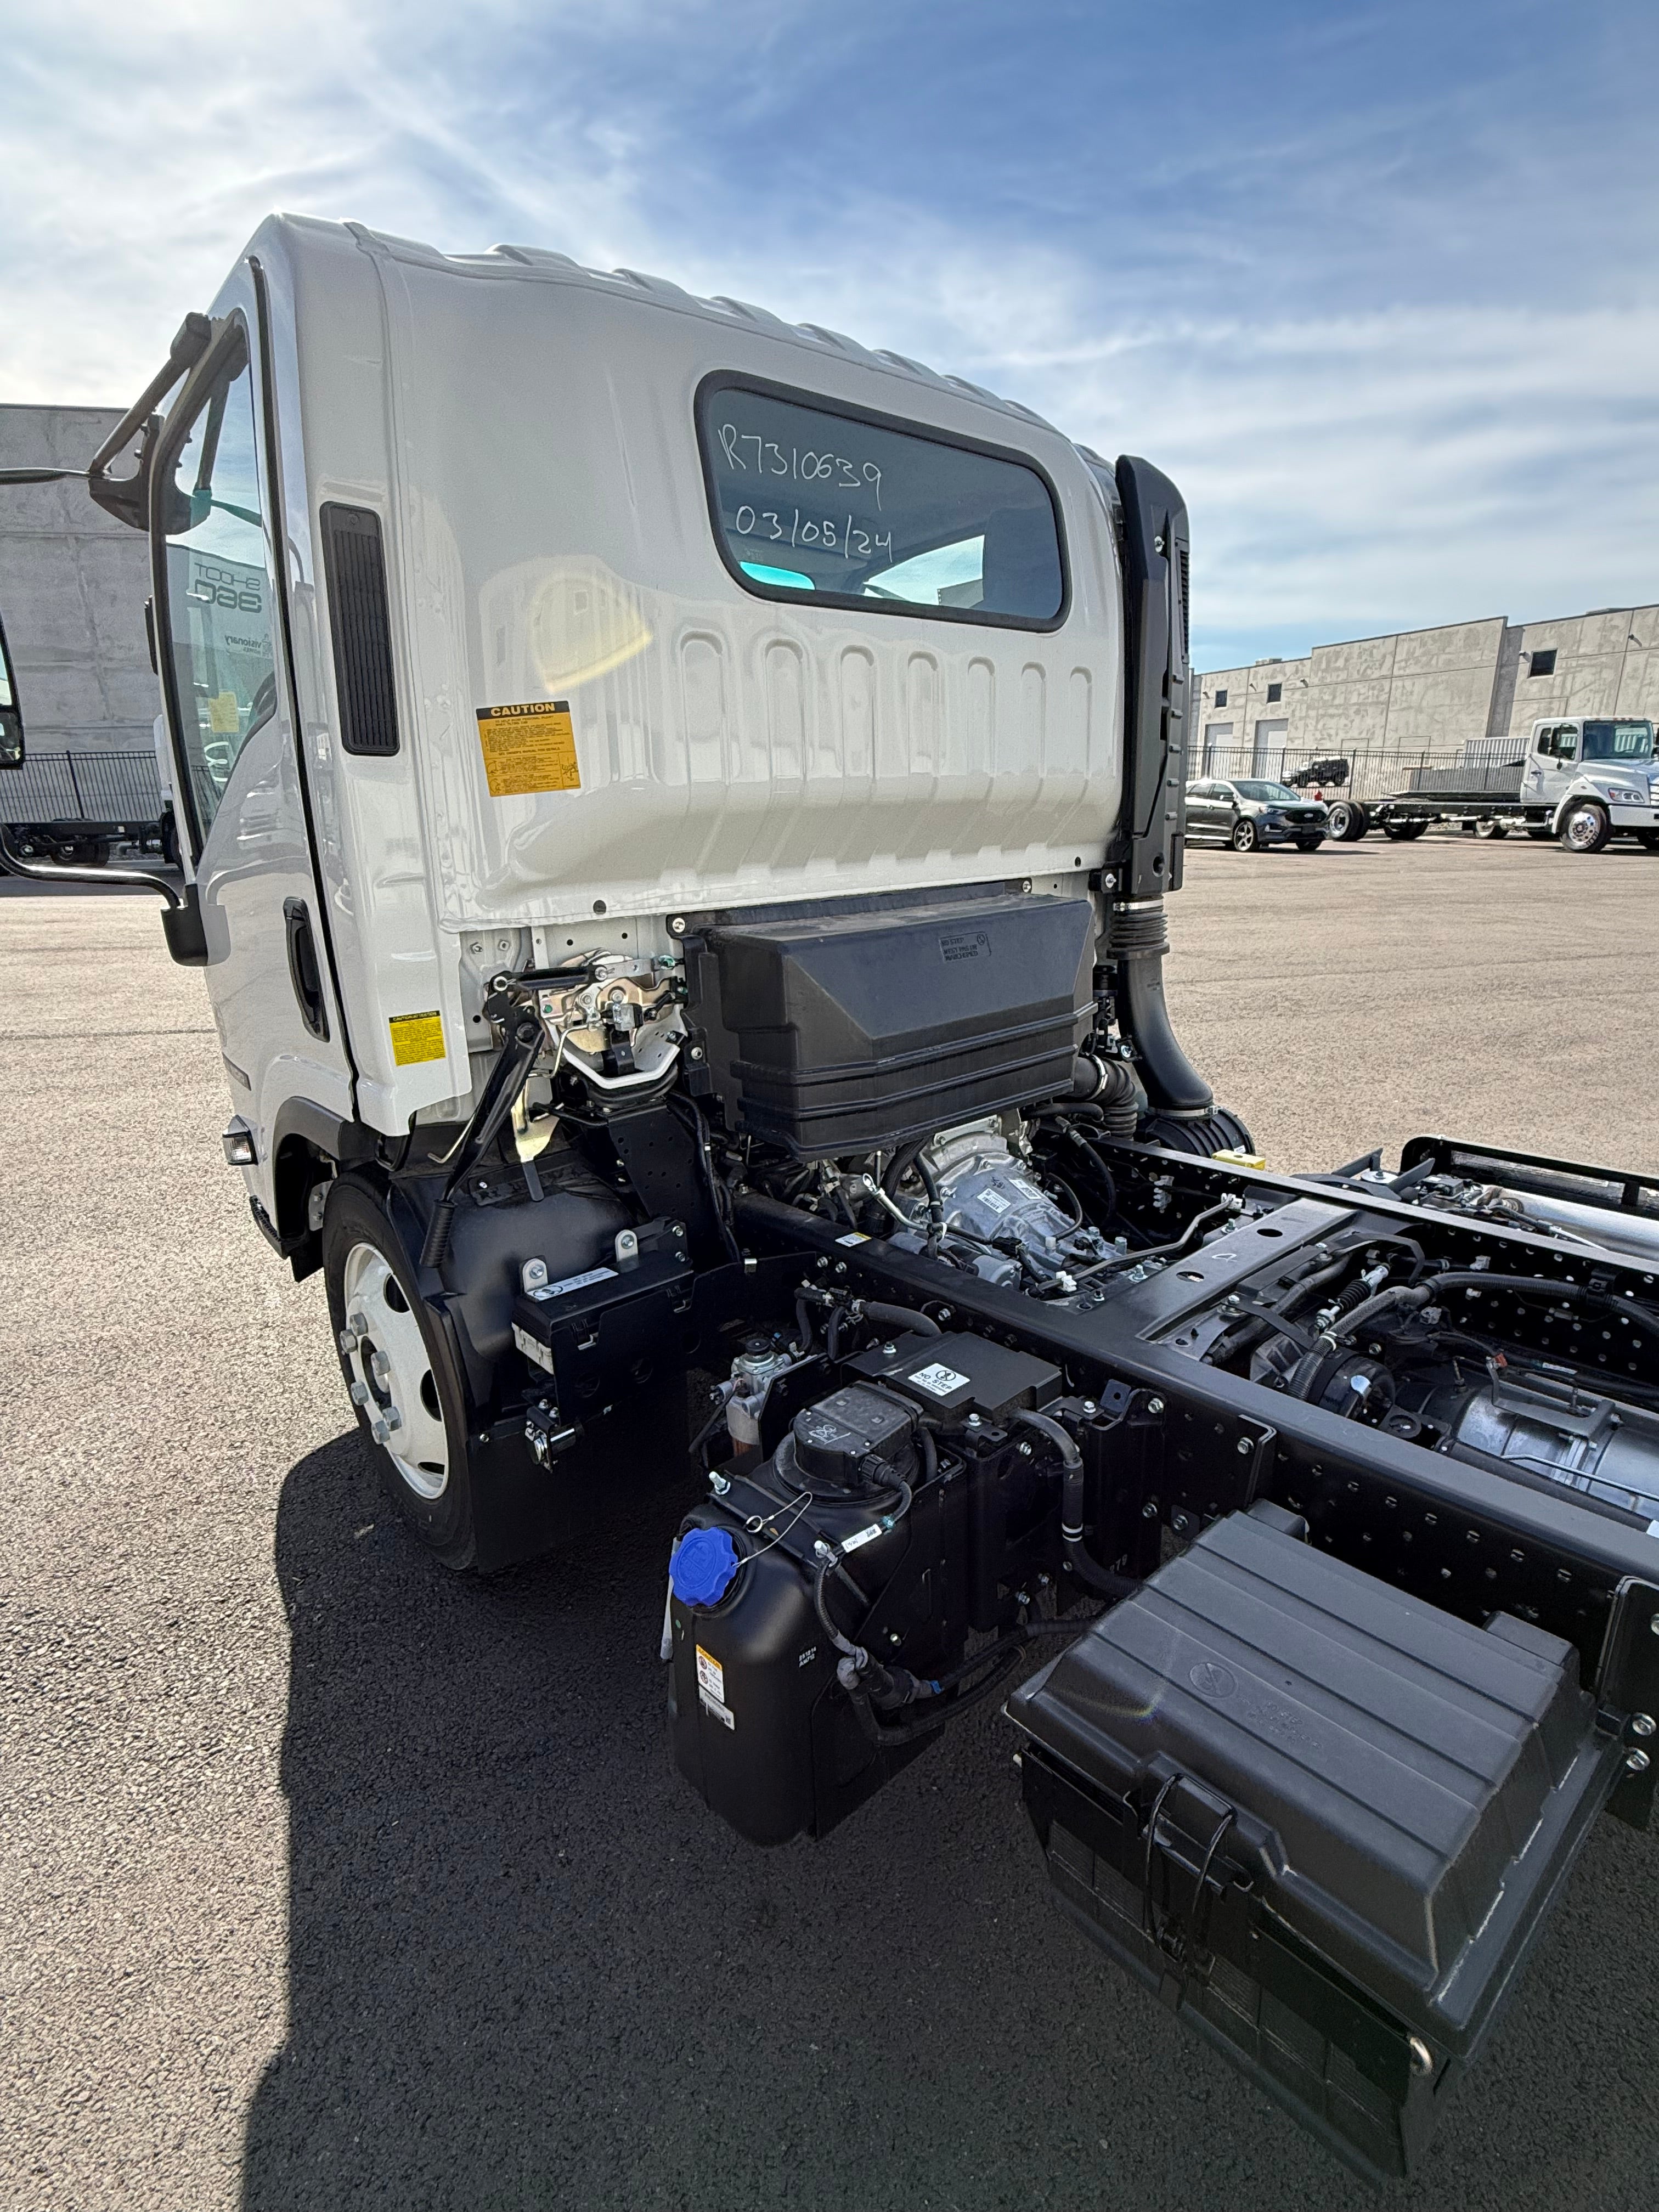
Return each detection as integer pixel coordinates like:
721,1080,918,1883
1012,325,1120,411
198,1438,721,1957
697,376,1068,630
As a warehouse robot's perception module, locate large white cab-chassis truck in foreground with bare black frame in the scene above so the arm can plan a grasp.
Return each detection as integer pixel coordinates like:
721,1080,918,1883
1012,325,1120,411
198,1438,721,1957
3,219,1659,2176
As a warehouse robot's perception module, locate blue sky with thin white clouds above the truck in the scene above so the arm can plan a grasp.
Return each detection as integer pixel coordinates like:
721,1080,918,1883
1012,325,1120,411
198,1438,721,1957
0,0,1659,666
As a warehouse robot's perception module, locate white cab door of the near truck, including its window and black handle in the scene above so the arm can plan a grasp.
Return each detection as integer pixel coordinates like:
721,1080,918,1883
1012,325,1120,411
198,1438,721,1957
150,285,352,1219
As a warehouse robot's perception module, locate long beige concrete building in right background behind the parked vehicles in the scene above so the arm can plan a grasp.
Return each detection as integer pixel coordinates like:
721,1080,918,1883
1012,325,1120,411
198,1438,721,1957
1192,606,1659,774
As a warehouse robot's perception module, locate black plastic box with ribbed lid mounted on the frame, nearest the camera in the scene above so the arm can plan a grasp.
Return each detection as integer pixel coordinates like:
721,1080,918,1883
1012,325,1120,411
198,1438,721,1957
1009,1506,1621,2179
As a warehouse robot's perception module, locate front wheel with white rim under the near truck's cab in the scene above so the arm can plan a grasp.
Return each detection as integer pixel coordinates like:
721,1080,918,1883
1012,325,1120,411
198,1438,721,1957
323,1175,476,1568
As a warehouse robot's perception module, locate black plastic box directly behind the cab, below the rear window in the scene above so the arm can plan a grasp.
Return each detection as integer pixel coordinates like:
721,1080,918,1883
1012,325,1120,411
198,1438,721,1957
690,891,1095,1159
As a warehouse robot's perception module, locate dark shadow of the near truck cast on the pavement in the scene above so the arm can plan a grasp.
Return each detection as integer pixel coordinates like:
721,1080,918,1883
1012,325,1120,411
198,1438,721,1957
244,1434,1659,2212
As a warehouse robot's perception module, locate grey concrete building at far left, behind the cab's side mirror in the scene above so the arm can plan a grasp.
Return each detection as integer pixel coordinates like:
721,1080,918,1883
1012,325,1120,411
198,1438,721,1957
0,405,157,754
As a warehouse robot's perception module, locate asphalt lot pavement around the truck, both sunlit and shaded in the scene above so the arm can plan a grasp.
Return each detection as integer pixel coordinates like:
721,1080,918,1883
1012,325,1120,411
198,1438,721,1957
0,838,1659,2212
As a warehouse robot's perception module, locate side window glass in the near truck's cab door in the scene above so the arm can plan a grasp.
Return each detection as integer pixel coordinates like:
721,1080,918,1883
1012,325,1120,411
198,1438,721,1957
157,327,276,838
